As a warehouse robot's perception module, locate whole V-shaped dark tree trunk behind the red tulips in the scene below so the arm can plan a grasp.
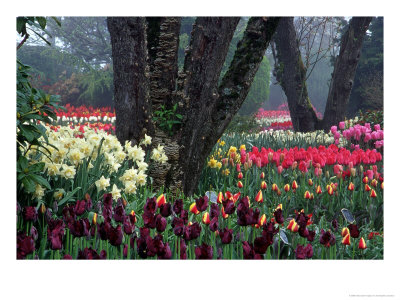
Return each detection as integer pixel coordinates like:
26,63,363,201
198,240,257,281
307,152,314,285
274,17,372,132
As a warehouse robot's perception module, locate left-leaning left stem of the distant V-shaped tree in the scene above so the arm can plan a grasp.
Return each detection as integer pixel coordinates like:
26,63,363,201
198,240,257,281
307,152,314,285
274,17,319,132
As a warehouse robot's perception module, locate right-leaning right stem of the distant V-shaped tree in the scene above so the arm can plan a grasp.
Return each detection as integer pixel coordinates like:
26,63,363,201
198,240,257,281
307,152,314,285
322,17,372,131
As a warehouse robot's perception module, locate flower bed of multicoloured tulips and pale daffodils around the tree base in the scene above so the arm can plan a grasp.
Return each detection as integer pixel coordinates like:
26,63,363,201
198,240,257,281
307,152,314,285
17,108,384,259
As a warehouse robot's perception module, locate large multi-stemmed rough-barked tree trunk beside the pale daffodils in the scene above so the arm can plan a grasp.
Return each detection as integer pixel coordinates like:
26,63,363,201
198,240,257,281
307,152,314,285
108,17,279,195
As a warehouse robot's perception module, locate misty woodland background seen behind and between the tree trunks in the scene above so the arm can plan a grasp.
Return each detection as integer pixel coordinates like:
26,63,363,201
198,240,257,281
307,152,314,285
17,17,383,118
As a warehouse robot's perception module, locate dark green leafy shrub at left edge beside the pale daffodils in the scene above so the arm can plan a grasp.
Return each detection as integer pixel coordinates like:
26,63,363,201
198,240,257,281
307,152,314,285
17,61,61,198
